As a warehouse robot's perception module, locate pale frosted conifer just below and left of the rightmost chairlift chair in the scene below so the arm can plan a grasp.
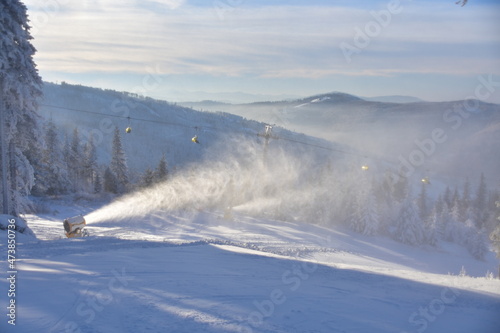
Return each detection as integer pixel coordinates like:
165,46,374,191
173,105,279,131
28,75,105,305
394,195,424,245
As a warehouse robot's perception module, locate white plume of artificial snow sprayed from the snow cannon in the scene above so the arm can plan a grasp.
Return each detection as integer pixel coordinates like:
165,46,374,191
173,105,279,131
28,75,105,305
86,138,364,224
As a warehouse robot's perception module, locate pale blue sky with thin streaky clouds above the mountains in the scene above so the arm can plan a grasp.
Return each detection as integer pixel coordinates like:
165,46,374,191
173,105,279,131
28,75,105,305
25,0,500,103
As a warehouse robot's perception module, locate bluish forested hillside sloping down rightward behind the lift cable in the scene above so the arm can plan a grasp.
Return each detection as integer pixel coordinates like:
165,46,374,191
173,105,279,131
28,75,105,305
39,83,341,173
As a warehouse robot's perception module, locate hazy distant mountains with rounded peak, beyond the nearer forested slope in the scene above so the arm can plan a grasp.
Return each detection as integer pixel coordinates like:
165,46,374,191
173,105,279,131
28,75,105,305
181,92,500,182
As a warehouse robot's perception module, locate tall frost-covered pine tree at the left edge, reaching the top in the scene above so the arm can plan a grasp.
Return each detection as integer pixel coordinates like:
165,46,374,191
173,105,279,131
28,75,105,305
0,0,42,215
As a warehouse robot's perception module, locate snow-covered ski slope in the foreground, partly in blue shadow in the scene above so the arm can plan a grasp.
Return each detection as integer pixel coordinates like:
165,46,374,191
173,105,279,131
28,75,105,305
0,198,500,333
